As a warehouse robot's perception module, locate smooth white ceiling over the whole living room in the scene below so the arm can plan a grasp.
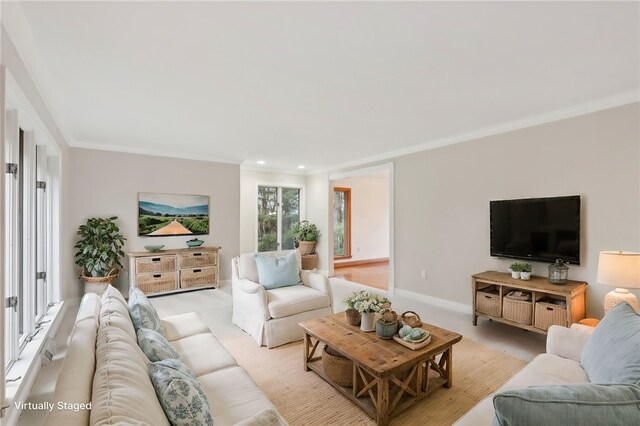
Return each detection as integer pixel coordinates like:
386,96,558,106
12,1,640,171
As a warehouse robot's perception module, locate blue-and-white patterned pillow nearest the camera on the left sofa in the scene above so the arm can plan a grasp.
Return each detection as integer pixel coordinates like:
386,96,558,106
149,359,213,426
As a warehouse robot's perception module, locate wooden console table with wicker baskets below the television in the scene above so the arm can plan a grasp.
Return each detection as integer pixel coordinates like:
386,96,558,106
471,271,587,334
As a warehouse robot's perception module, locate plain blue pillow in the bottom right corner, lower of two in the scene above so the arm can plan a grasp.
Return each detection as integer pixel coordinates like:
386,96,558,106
493,383,640,426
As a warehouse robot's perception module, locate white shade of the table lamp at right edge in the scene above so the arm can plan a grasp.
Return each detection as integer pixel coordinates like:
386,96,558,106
598,251,640,288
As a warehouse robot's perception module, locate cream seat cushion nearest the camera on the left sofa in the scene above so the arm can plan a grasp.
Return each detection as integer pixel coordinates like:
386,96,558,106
198,367,282,425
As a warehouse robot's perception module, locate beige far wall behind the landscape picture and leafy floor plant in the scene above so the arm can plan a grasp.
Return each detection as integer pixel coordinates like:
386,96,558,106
64,148,240,298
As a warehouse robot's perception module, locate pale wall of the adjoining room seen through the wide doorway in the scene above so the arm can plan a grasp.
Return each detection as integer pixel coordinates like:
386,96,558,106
331,172,389,263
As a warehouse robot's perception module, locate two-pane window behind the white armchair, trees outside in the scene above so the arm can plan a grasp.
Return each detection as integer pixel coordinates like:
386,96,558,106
257,186,301,252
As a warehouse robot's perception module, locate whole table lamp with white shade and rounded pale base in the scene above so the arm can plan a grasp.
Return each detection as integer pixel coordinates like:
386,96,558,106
598,251,640,315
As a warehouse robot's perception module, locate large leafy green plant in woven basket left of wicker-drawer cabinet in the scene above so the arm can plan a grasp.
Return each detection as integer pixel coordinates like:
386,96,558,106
75,216,126,284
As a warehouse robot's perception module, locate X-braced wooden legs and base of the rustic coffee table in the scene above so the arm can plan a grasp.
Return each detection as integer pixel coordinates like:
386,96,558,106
303,332,453,425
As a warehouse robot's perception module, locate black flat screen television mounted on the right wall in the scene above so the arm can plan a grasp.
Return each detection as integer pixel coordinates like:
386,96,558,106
489,195,580,265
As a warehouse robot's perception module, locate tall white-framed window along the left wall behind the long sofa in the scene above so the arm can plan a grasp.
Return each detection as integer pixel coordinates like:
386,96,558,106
3,110,51,369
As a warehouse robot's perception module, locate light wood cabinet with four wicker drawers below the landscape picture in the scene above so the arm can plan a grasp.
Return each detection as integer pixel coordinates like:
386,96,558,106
127,247,220,295
